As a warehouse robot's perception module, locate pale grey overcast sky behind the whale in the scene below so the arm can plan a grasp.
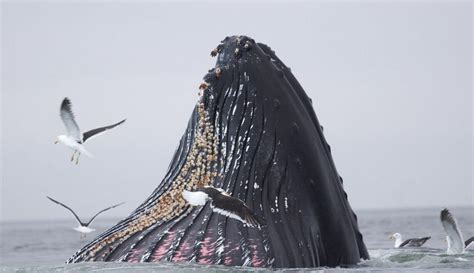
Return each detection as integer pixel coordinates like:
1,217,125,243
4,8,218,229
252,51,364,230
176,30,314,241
0,2,474,220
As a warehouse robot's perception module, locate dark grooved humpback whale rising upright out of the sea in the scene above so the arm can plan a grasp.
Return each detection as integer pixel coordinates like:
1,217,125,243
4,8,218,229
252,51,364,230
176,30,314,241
67,36,369,268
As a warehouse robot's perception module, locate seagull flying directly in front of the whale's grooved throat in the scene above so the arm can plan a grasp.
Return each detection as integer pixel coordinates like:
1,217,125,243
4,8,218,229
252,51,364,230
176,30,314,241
182,186,265,228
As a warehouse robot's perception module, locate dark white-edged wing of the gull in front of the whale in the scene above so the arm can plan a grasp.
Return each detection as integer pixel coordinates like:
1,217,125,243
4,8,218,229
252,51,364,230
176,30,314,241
211,193,265,227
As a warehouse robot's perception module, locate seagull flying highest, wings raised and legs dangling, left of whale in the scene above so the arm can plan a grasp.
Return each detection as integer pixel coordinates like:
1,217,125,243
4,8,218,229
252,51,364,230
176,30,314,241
54,98,125,165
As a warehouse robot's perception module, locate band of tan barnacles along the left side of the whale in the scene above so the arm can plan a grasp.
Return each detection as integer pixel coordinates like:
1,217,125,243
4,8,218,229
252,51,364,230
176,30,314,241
84,91,218,258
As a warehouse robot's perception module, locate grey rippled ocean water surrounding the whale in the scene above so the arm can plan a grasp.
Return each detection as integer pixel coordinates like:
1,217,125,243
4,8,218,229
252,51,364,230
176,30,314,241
0,207,474,273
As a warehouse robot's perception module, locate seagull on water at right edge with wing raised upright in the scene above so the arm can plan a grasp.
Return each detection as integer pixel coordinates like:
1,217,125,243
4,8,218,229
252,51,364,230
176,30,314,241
440,209,474,255
